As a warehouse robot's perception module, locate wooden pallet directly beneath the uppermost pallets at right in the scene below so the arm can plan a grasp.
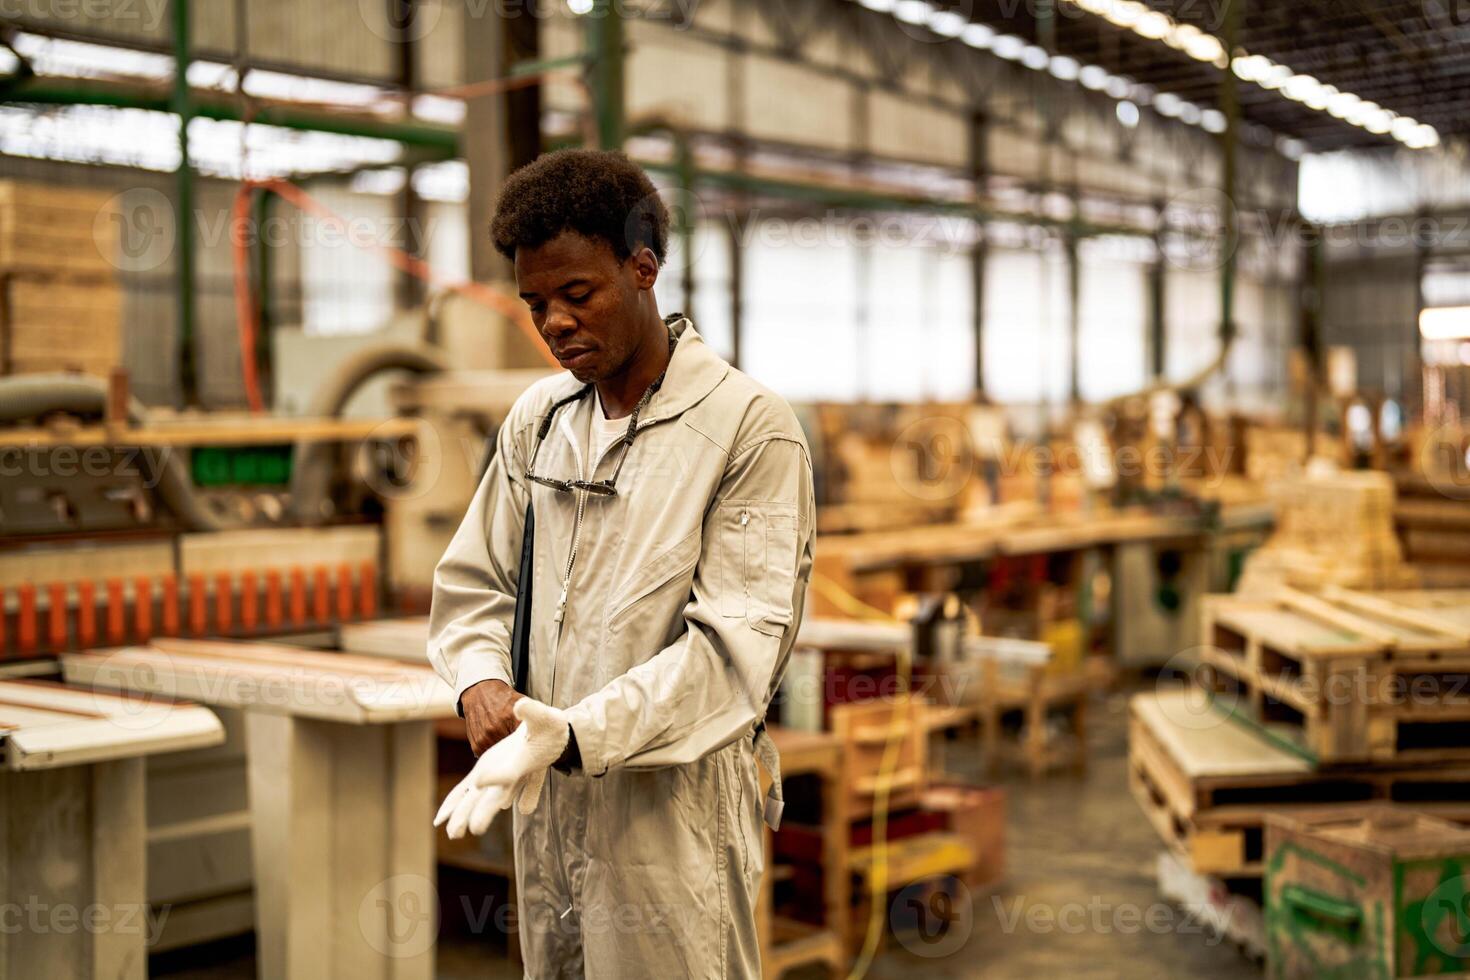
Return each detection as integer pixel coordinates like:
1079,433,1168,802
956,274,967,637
1129,692,1470,877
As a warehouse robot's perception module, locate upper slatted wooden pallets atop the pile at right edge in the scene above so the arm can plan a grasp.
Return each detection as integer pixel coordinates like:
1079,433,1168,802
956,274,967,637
1201,589,1470,764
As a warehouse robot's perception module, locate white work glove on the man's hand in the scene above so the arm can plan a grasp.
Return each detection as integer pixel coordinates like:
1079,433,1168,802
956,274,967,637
434,698,569,839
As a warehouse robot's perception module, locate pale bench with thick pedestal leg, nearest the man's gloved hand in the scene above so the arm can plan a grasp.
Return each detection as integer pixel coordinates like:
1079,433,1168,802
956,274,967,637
62,639,454,980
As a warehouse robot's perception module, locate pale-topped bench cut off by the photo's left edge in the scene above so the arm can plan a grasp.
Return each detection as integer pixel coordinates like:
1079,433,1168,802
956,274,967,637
0,680,225,980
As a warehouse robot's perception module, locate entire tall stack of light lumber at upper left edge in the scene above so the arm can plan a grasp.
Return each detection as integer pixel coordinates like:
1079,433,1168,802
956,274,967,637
0,181,122,376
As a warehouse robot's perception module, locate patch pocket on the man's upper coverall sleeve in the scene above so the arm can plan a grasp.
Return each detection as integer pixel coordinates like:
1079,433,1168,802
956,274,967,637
714,501,798,636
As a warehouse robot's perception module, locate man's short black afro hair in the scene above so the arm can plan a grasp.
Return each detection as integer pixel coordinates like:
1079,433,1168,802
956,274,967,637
490,150,669,264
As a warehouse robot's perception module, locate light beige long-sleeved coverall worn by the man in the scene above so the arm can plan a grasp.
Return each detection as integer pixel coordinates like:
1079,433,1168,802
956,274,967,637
429,317,814,980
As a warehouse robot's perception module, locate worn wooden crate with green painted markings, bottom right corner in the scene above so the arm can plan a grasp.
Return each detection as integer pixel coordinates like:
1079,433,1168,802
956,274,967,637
1264,805,1470,980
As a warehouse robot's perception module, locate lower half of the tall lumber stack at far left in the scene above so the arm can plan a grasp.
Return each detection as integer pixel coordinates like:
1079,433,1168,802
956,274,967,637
0,275,122,376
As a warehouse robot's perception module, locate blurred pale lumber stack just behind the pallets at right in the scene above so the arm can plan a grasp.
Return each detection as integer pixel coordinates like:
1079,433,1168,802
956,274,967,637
1239,472,1417,592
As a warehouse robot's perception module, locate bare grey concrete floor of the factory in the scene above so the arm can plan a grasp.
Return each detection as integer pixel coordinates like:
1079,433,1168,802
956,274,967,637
153,695,1260,980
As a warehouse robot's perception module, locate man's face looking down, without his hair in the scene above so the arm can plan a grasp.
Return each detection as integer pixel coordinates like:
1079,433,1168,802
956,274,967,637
516,232,659,385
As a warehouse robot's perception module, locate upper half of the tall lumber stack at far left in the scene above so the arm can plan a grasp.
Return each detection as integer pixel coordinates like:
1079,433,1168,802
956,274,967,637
0,181,121,279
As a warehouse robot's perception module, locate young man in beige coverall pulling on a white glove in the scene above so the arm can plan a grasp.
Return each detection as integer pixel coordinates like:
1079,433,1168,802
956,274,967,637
429,150,813,980
